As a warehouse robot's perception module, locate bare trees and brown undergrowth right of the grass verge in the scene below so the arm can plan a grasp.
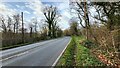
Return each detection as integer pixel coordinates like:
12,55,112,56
71,1,120,65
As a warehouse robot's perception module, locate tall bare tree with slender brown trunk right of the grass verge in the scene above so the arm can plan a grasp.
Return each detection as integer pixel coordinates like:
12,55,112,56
72,1,90,39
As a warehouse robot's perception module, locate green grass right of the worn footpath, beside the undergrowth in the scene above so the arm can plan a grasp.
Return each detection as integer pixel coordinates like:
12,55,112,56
75,37,103,66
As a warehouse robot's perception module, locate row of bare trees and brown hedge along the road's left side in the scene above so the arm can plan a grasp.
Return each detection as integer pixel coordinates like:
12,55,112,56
0,6,63,47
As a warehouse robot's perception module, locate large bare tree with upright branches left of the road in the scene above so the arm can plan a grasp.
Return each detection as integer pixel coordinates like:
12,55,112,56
44,6,58,38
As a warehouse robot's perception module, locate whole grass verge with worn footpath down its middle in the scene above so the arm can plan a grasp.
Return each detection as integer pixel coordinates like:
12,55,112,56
56,36,103,66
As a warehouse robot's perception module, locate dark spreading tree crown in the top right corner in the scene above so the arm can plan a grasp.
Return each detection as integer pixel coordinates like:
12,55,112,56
92,2,120,31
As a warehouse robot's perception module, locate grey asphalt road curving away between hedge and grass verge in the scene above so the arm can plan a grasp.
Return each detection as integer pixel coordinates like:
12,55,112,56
2,37,70,66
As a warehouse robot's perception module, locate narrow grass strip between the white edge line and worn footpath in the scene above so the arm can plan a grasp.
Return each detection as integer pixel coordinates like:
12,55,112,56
57,37,76,66
